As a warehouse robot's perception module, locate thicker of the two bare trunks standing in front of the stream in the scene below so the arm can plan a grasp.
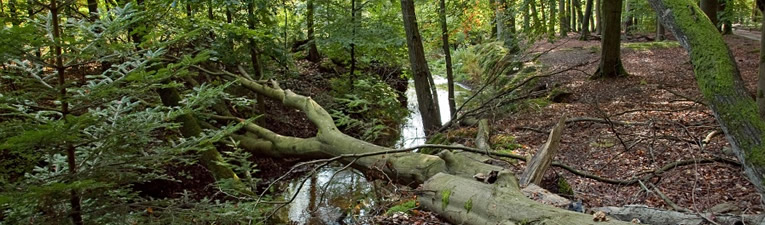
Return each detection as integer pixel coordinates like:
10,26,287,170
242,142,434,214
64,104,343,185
401,0,441,135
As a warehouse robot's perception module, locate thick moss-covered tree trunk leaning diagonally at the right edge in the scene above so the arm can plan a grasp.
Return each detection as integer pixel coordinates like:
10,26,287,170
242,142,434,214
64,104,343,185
649,0,765,205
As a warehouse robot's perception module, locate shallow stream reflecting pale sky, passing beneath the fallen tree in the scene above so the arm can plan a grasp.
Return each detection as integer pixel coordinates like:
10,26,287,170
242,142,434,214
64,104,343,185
277,76,469,225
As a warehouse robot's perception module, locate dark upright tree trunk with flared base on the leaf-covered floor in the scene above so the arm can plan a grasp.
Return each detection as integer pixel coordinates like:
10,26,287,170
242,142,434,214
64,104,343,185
592,0,627,78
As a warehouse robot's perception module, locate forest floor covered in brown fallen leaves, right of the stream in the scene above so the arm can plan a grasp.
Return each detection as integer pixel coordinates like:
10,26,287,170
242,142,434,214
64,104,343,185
480,32,763,213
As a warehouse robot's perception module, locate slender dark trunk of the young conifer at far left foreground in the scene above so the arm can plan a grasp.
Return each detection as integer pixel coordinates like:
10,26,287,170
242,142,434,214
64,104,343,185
48,0,83,225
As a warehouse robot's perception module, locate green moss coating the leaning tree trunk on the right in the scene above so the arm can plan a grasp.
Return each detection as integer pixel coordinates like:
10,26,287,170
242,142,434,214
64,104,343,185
663,0,765,167
